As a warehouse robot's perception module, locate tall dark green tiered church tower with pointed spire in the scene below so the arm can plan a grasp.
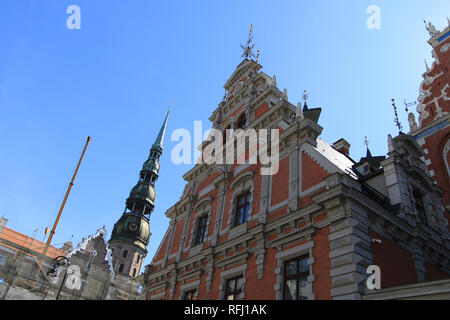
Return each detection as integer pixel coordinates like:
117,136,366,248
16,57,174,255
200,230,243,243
109,111,169,277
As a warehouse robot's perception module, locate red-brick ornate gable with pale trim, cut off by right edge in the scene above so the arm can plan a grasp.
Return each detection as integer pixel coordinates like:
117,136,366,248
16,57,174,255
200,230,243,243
409,21,450,215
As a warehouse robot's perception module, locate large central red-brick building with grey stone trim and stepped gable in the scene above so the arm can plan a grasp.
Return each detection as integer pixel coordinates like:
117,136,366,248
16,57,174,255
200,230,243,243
144,25,450,300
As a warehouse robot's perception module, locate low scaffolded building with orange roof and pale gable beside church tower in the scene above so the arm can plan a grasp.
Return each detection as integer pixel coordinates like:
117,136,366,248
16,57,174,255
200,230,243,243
0,218,141,300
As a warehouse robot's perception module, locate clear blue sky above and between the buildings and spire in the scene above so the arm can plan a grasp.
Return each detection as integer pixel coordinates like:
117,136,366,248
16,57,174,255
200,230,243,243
0,0,450,270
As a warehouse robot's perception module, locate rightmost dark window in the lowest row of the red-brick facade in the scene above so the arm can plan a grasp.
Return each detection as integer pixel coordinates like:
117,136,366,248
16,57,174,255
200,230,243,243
284,256,309,300
